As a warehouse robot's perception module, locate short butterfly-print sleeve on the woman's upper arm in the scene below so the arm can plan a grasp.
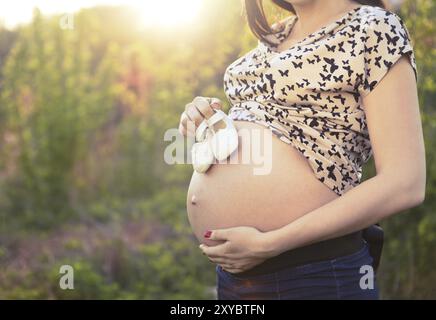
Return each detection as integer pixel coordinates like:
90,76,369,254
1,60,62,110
359,10,418,96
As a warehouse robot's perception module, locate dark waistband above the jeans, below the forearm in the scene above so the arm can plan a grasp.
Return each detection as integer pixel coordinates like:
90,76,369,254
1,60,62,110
235,231,364,277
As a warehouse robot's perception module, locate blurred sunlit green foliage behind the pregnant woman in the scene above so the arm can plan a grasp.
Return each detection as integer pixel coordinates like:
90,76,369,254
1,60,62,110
0,0,436,299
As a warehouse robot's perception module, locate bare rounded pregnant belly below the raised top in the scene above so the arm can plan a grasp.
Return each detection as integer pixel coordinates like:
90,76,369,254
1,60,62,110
187,121,338,245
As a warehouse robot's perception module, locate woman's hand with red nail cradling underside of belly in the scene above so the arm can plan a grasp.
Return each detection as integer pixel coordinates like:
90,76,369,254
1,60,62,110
200,227,276,273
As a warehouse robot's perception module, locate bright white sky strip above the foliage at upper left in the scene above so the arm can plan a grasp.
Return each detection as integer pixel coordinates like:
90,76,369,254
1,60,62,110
0,0,202,27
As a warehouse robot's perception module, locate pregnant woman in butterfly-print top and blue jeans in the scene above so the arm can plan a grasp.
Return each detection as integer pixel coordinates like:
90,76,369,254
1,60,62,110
179,0,425,299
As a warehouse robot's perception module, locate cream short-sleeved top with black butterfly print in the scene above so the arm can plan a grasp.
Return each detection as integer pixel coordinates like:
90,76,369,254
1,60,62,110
224,5,418,195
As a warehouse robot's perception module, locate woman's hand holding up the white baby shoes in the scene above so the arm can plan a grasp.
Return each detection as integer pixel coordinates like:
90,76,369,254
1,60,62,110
179,97,222,136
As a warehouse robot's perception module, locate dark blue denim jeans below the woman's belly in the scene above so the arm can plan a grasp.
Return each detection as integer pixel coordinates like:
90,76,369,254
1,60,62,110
216,242,379,300
